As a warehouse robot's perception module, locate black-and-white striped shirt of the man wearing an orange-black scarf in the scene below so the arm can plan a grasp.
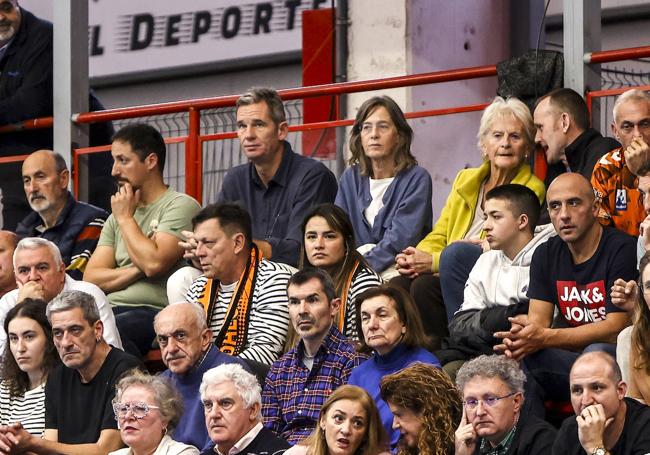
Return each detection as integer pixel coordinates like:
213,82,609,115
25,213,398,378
187,259,296,365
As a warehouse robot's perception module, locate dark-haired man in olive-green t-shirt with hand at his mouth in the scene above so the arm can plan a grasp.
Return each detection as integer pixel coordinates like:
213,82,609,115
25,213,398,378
84,124,199,356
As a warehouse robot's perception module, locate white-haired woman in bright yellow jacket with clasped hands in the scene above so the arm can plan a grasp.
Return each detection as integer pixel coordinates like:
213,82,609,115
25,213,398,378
393,97,546,346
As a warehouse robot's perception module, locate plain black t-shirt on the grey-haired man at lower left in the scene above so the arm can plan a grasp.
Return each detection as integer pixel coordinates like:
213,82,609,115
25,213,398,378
45,348,141,444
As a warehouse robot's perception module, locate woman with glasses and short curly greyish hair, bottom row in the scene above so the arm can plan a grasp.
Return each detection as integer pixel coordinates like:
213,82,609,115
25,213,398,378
110,370,199,455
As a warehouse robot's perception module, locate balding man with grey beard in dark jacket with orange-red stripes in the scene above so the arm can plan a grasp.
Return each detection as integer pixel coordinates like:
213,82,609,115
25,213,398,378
16,150,108,280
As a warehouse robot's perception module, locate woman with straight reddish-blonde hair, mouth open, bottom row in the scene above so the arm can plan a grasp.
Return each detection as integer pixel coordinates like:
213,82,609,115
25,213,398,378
285,385,388,455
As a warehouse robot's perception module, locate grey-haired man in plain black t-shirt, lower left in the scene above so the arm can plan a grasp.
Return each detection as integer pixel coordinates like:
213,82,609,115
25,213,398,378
3,291,140,454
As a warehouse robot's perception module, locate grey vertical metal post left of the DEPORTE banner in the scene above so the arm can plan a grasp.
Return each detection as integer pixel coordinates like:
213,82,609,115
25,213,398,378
54,0,88,199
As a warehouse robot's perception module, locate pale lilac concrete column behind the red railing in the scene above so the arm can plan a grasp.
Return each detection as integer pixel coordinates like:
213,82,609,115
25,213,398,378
408,0,510,219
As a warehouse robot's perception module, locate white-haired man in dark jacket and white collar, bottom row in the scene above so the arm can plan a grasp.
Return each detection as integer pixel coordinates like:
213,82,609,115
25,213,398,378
200,363,289,455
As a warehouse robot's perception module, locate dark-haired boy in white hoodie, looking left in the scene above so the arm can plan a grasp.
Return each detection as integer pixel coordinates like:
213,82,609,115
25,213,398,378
442,184,555,362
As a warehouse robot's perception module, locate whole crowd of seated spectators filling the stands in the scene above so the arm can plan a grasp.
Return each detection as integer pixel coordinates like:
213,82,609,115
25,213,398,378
0,0,650,455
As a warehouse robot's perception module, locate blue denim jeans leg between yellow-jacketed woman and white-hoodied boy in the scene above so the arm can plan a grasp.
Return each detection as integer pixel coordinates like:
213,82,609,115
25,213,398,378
439,242,483,322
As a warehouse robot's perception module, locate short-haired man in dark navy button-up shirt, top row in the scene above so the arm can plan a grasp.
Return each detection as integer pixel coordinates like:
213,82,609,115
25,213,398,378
218,88,337,266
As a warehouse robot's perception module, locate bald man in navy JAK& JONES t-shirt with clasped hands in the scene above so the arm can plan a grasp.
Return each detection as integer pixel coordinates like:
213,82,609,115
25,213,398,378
495,173,638,416
